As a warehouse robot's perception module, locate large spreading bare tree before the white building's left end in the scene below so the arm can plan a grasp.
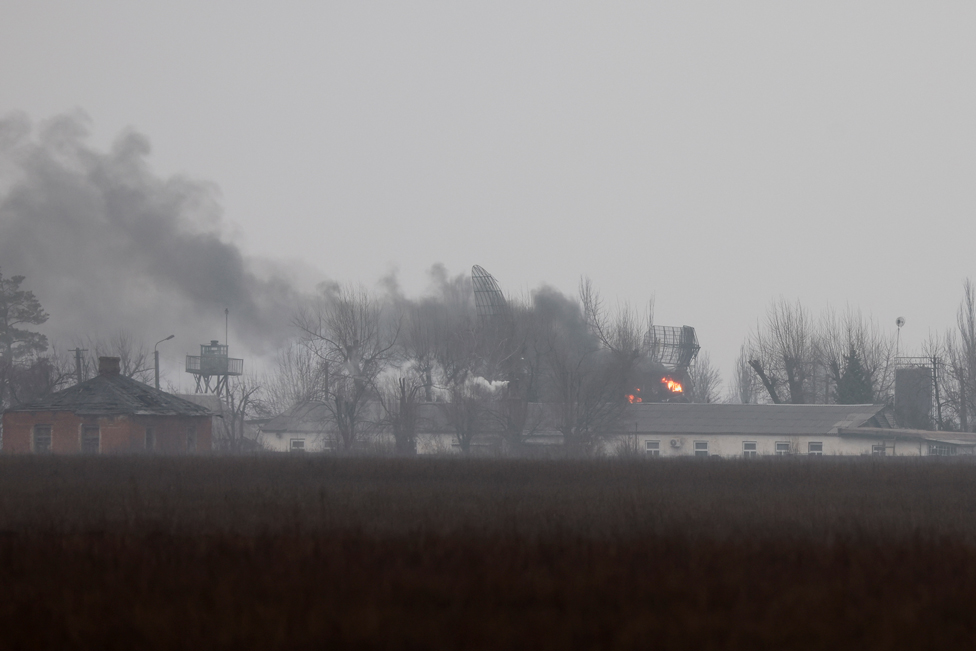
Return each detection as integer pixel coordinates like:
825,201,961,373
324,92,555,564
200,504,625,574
294,287,401,451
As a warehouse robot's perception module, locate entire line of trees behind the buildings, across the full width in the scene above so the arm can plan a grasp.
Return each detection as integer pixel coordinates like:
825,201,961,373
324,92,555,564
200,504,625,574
0,264,976,453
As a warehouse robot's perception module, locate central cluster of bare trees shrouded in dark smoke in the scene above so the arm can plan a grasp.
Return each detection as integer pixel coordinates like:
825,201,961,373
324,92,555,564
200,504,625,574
274,277,672,453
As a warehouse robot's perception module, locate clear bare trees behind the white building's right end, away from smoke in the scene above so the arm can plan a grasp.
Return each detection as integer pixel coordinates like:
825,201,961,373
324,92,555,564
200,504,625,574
727,279,976,432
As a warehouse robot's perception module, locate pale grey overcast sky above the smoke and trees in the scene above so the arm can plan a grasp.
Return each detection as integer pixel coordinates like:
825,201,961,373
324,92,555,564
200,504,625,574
0,0,976,377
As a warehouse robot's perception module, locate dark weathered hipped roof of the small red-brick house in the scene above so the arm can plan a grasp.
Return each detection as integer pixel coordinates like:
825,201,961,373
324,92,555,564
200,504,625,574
7,374,211,416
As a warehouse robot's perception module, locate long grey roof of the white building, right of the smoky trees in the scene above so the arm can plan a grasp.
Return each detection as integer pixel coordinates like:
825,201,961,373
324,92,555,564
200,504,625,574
619,402,891,436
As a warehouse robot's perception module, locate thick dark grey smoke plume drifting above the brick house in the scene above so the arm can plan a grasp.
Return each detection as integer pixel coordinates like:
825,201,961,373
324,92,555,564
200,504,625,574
0,115,299,364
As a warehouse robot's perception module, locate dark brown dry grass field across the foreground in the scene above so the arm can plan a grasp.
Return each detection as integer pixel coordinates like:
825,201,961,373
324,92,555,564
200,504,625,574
0,457,976,650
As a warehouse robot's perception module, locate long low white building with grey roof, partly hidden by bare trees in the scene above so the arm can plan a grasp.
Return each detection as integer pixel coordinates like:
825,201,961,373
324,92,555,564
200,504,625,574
260,402,976,458
